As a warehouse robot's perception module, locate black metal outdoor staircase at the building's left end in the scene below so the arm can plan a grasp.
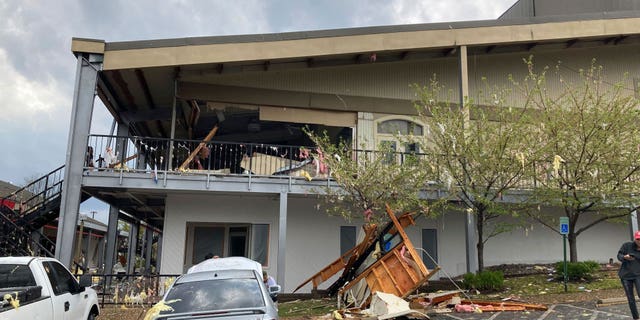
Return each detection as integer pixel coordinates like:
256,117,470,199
0,165,83,257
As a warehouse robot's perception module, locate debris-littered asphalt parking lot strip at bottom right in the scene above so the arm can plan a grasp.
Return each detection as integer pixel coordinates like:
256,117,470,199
429,302,631,320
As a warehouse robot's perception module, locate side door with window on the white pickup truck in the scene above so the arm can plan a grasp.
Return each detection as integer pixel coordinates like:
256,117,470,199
43,261,89,320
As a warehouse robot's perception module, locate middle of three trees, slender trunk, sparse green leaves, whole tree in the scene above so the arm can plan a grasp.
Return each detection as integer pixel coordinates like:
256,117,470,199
416,78,534,271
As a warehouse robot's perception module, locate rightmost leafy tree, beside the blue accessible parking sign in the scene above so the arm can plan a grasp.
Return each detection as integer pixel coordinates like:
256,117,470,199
514,59,640,262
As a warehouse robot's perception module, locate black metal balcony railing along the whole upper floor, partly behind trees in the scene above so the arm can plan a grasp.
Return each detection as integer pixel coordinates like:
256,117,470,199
85,135,640,194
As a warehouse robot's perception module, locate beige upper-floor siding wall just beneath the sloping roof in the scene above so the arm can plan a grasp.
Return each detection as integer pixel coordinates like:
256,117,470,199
195,45,640,112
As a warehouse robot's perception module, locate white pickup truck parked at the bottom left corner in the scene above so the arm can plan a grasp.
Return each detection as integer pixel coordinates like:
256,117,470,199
0,257,100,320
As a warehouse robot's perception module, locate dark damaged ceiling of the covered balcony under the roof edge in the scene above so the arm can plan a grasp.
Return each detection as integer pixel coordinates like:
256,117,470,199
98,35,640,143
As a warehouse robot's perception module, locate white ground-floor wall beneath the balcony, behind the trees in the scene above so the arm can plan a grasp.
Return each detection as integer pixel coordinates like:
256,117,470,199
161,195,629,292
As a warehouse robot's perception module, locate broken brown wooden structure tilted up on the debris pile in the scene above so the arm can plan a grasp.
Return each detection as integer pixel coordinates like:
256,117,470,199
294,205,439,308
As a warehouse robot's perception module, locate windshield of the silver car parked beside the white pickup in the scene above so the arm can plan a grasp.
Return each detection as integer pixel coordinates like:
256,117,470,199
162,278,265,314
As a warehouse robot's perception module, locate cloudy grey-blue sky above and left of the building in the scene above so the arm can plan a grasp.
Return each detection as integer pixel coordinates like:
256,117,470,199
0,0,516,220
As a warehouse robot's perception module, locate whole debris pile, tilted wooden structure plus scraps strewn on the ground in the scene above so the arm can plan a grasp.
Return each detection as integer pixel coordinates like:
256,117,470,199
294,206,548,320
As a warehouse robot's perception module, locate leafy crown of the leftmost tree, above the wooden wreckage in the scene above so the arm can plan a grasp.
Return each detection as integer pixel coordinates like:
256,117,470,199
307,132,428,223
